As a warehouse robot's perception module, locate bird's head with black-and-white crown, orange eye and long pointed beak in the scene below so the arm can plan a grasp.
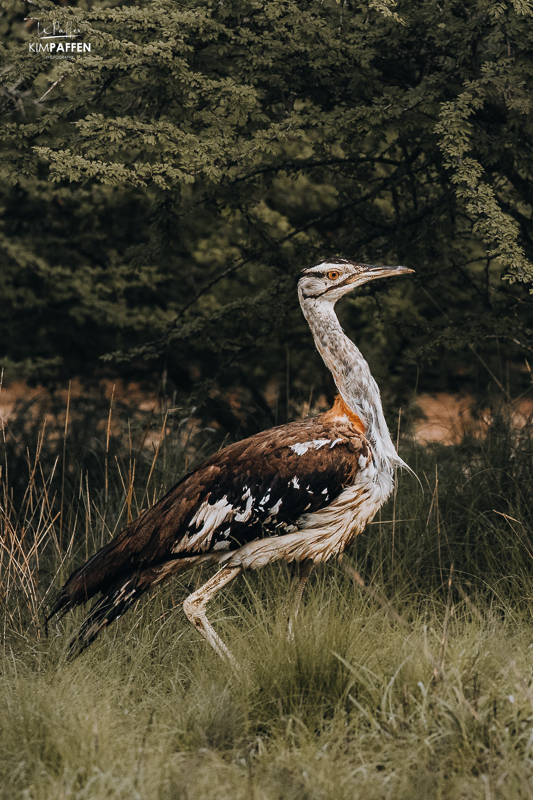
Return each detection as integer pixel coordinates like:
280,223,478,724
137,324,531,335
298,258,414,303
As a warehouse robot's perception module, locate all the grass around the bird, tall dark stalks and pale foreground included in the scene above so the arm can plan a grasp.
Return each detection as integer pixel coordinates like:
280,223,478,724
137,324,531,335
0,396,533,800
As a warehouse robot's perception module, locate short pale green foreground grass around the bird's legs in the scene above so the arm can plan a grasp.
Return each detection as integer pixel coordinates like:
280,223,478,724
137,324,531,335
5,567,533,800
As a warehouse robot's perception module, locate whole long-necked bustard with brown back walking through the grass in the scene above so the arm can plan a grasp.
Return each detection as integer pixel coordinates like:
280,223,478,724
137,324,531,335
46,257,414,664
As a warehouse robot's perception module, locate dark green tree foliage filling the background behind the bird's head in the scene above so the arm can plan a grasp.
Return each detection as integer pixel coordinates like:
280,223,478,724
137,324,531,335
0,0,533,424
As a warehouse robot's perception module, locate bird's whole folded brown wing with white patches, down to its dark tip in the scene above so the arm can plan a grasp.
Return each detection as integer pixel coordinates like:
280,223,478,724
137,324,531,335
50,415,371,616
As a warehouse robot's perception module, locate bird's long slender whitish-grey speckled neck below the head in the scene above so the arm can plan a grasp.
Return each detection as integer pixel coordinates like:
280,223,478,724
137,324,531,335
301,298,403,469
